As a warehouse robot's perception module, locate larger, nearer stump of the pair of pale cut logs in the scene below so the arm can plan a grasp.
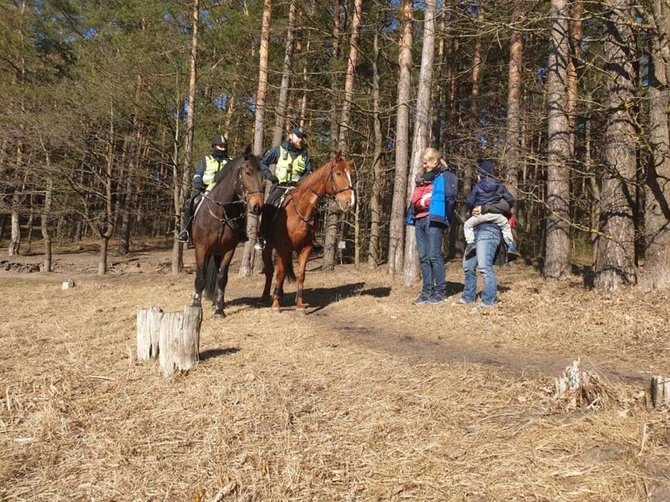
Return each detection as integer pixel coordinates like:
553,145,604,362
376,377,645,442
158,307,202,377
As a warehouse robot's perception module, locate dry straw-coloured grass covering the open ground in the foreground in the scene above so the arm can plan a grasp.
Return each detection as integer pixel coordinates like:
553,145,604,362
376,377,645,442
0,248,670,501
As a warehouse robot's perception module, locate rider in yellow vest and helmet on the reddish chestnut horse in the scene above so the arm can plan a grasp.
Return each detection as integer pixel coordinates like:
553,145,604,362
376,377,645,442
257,127,314,248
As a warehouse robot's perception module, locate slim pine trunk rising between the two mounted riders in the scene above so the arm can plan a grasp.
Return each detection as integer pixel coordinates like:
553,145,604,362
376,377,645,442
239,0,272,277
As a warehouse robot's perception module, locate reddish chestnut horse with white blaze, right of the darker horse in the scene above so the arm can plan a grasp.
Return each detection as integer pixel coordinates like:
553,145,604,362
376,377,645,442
262,152,356,312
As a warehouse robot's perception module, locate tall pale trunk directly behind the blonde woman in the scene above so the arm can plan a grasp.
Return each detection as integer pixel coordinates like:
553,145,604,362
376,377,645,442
404,0,436,286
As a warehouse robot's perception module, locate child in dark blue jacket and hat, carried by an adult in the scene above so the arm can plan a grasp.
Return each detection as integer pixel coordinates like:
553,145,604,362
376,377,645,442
463,160,521,258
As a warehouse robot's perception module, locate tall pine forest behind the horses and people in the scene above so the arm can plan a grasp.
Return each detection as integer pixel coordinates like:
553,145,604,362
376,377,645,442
0,0,670,290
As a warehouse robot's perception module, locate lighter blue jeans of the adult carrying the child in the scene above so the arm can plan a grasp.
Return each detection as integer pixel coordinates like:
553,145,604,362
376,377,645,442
461,223,501,305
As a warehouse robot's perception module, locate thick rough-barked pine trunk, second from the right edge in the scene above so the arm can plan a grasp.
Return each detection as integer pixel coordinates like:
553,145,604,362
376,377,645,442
595,0,637,291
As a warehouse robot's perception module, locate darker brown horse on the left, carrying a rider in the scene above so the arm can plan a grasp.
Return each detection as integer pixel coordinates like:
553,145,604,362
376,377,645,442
191,148,263,317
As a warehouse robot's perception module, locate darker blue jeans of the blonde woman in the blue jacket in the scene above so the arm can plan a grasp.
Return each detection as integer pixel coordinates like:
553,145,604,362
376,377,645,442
414,216,447,298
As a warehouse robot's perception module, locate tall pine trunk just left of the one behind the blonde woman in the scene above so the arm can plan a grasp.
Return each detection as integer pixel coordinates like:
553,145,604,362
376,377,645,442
388,0,413,276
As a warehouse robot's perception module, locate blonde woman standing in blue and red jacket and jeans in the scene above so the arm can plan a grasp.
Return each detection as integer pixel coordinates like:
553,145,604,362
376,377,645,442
407,148,458,305
